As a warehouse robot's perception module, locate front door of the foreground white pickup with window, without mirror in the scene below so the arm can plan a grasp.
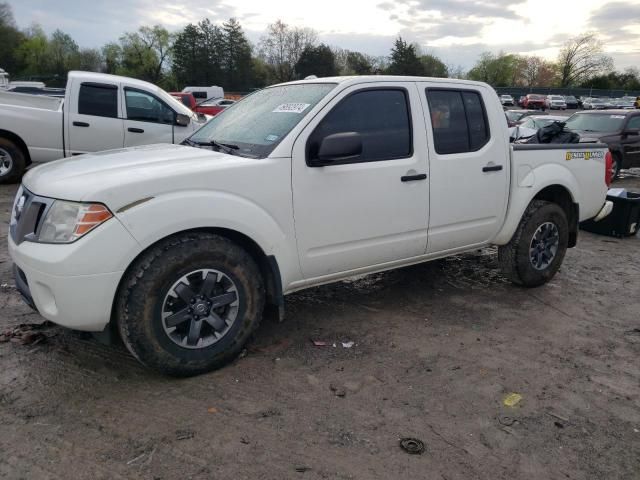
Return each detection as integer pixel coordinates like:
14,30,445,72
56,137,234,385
292,82,429,279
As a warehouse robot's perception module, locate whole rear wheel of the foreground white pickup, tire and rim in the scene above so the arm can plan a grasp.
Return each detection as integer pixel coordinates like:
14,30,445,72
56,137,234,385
498,200,569,287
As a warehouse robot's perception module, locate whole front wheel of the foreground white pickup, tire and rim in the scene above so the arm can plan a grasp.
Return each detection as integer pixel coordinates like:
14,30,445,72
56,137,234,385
116,233,264,376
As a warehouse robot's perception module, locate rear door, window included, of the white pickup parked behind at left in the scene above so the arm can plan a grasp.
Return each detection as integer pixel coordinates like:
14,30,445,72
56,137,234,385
66,82,124,155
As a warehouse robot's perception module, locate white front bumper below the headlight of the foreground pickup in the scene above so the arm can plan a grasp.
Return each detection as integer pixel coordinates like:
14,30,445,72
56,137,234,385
9,219,139,332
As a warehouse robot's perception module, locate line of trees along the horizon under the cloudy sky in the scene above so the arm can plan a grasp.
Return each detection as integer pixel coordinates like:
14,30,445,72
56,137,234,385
0,3,640,92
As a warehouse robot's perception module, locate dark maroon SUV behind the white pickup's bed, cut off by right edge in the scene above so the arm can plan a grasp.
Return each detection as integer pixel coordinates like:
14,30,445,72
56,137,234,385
566,110,640,177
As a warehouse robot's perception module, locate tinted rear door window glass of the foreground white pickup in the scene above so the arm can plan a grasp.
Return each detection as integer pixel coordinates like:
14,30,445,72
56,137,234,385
427,89,489,155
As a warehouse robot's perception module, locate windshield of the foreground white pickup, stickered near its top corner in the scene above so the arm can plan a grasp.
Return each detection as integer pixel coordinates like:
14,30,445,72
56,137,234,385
187,83,336,158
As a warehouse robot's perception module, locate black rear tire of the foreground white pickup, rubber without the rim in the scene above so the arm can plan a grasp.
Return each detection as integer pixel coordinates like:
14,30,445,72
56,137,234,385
498,200,569,287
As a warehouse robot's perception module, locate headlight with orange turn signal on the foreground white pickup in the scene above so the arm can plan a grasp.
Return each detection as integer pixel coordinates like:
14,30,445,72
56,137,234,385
37,200,113,243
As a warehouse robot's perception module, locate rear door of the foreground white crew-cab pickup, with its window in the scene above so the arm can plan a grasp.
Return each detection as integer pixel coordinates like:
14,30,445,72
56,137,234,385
420,82,509,253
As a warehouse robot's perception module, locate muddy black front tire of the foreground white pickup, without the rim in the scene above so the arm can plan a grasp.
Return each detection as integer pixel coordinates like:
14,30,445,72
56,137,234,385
115,232,265,376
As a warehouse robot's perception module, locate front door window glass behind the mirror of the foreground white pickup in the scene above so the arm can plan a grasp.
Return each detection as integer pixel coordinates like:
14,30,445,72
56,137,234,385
308,89,413,162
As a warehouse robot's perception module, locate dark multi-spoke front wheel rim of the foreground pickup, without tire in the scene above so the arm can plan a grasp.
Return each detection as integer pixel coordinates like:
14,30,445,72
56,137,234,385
162,269,240,349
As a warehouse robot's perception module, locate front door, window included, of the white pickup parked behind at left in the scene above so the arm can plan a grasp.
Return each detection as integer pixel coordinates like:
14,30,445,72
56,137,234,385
124,87,176,147
